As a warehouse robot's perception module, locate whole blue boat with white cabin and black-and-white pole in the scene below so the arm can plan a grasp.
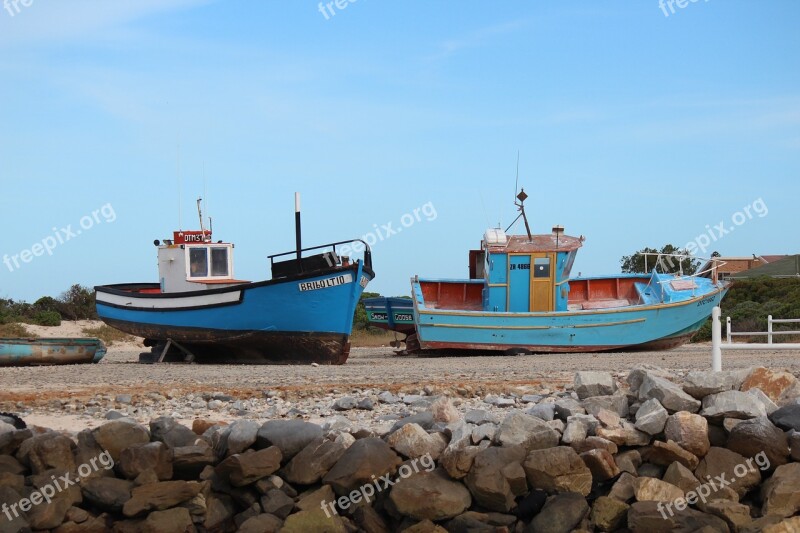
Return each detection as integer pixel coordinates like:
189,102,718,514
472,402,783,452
95,193,375,364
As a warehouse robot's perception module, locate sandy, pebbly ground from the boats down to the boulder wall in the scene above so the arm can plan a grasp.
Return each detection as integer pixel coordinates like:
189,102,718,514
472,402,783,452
0,321,800,431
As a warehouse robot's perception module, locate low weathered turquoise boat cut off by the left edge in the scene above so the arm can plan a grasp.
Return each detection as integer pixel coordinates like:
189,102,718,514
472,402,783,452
0,338,106,366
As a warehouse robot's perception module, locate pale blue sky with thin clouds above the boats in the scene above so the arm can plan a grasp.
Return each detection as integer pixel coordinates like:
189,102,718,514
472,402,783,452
0,0,800,301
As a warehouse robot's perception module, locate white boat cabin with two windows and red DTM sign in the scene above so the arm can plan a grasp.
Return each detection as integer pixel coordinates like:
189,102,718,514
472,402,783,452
158,230,247,293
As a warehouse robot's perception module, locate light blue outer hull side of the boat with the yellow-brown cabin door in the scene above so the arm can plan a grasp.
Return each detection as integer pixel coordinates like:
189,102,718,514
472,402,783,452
408,275,727,353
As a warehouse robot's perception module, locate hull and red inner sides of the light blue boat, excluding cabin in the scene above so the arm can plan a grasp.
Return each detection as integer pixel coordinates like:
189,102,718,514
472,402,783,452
407,270,727,353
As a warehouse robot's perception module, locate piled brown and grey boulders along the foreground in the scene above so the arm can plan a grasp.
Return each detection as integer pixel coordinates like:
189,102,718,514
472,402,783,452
0,365,800,533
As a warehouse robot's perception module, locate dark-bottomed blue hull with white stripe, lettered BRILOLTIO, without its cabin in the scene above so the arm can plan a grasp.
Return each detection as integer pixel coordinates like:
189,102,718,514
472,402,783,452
96,263,373,364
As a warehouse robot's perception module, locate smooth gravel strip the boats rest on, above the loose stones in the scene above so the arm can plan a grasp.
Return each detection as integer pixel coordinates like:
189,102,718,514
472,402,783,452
0,344,800,401
